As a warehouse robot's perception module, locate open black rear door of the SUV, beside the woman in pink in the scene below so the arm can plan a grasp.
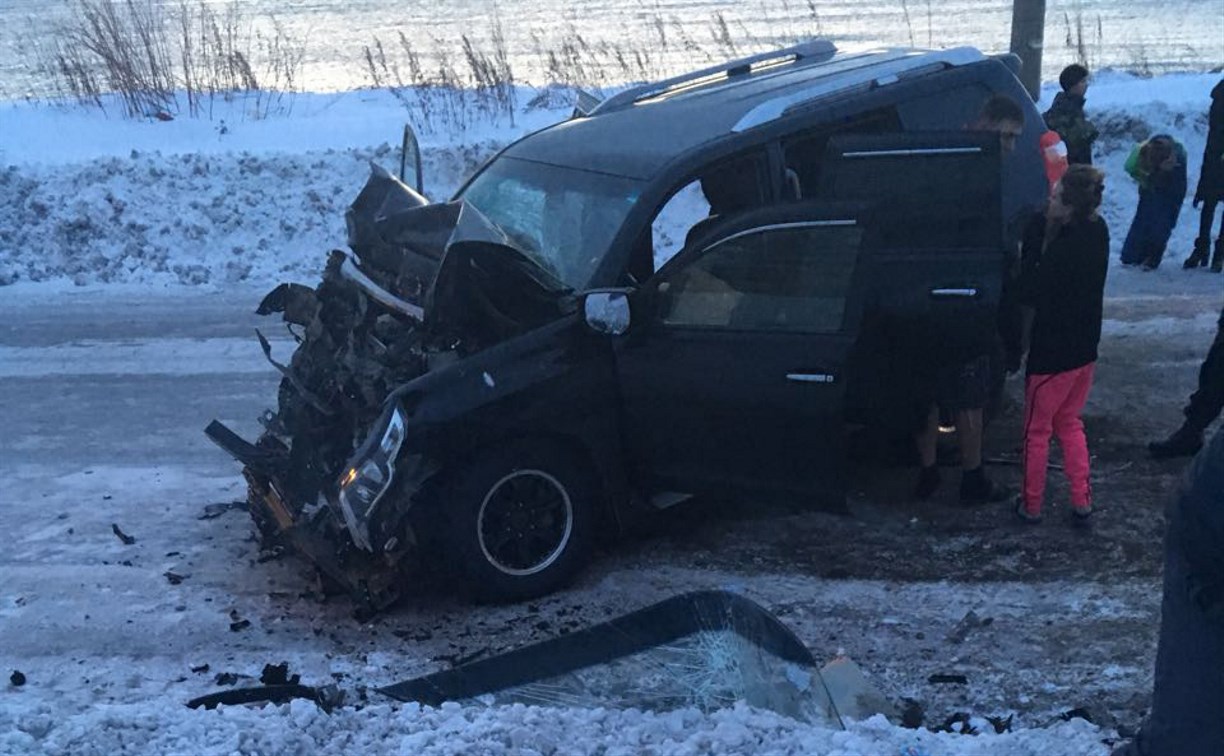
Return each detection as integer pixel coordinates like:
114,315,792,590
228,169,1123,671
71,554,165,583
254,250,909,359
819,131,1015,428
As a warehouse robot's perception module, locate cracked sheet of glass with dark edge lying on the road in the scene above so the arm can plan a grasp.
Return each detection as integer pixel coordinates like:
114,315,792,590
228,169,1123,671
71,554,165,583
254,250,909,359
381,591,842,727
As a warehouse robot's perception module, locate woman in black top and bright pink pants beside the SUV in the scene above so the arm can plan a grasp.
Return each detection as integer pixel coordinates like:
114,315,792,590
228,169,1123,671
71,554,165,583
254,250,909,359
1016,165,1109,522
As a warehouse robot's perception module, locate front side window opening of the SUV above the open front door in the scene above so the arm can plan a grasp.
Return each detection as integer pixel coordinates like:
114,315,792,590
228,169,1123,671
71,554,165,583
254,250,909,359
651,152,767,270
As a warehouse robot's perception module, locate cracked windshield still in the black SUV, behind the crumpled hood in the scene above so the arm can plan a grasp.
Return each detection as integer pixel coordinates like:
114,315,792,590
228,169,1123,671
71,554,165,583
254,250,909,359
460,158,640,289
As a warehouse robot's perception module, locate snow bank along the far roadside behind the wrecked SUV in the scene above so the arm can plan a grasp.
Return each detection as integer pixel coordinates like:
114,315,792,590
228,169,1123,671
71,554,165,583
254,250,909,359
0,72,1218,290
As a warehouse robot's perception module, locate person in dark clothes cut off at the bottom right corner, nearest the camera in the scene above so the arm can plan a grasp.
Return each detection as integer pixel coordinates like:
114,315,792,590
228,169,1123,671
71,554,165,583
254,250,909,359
1114,432,1224,756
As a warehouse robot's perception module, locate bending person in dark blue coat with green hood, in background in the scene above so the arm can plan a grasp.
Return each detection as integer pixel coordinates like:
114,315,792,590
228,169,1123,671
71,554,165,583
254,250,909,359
1122,133,1186,270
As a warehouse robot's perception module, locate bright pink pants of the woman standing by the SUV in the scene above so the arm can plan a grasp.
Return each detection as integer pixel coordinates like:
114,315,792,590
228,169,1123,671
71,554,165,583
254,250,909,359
1024,362,1095,515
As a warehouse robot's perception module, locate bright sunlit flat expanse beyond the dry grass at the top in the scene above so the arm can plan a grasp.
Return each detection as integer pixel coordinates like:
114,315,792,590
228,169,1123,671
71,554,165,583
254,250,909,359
0,0,1224,98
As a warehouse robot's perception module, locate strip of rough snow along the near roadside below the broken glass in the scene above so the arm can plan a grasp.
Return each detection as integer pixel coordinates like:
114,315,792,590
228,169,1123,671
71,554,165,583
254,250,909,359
0,701,1109,756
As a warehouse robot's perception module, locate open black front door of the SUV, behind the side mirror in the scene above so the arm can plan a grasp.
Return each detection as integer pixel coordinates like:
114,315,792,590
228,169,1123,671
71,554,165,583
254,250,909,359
617,203,867,500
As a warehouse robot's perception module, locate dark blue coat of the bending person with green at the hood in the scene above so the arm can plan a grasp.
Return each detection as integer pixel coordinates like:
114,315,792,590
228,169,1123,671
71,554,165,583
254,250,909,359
1122,135,1186,265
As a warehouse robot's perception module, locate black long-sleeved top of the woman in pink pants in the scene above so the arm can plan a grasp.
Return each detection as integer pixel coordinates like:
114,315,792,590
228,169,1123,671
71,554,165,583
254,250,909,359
1020,215,1109,376
